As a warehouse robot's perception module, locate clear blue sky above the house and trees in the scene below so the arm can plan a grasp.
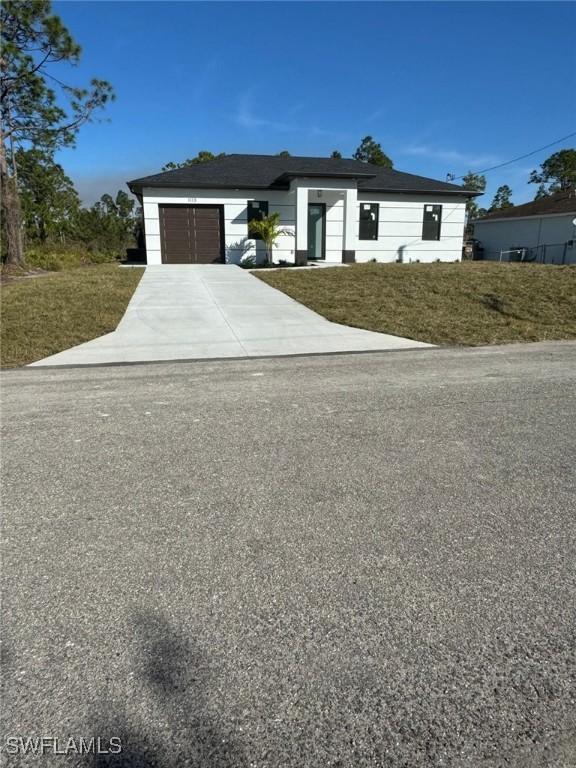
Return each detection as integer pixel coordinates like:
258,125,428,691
54,2,576,204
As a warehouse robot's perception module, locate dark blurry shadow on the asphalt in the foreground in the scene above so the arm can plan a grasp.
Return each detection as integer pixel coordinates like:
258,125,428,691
91,612,247,768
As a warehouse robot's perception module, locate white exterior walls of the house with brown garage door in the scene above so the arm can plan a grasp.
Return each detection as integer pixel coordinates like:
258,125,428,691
143,188,465,264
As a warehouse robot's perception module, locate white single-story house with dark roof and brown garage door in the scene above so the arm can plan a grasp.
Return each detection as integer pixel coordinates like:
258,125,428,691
128,155,476,264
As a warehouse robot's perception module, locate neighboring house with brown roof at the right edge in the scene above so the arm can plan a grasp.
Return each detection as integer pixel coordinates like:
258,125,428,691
474,191,576,264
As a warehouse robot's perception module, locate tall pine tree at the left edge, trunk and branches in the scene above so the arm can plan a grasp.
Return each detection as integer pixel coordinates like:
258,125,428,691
0,0,114,266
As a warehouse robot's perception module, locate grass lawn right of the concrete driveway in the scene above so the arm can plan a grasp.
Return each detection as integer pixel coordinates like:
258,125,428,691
257,262,576,346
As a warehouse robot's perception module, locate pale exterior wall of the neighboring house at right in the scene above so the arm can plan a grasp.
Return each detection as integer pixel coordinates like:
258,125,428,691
474,211,576,264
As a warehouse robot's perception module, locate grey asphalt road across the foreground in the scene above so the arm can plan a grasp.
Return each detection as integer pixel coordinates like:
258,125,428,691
1,343,576,768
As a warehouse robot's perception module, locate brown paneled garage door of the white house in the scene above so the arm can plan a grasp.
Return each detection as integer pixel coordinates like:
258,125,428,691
160,205,222,264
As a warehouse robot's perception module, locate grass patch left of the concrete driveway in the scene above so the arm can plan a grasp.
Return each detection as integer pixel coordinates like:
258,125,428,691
0,264,143,368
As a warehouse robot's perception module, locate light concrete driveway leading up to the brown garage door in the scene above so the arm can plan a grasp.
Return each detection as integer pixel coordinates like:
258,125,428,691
32,264,431,366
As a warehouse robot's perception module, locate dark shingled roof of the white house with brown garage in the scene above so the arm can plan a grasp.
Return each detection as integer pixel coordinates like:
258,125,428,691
128,155,479,195
